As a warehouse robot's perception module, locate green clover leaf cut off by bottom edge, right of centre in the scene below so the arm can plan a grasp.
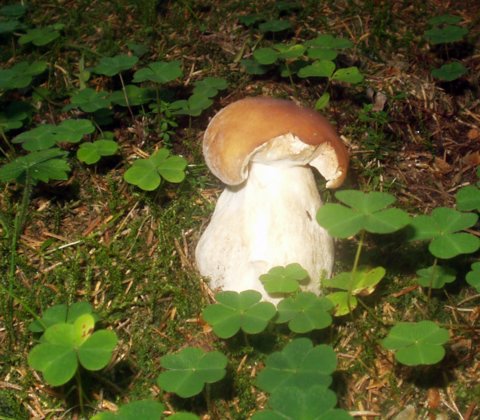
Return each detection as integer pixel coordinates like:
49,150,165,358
252,386,352,420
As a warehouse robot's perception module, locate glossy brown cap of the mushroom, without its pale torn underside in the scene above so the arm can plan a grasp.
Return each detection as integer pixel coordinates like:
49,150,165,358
203,97,348,187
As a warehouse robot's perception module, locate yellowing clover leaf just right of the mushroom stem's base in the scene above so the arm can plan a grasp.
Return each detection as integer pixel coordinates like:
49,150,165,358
323,267,385,316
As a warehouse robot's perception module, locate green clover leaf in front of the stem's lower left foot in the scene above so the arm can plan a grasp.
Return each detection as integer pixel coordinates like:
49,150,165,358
202,290,276,338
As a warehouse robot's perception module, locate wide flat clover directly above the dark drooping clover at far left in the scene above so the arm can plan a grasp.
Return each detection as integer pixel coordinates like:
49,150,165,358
13,119,95,151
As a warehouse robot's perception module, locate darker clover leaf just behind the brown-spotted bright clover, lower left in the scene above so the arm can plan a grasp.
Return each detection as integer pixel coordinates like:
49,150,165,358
28,302,96,332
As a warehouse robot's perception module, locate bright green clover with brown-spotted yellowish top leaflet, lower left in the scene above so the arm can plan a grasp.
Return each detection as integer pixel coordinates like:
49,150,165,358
28,313,117,386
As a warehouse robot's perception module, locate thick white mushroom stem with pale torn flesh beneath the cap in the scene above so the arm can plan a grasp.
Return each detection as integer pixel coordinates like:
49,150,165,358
196,135,334,302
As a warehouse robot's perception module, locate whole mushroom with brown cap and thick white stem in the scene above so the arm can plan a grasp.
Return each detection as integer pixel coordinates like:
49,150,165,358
195,97,348,302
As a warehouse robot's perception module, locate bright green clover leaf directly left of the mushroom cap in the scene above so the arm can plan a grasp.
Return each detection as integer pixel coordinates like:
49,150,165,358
124,149,187,191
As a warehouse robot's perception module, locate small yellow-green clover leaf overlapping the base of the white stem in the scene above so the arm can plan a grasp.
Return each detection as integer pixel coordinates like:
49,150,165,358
260,263,308,294
